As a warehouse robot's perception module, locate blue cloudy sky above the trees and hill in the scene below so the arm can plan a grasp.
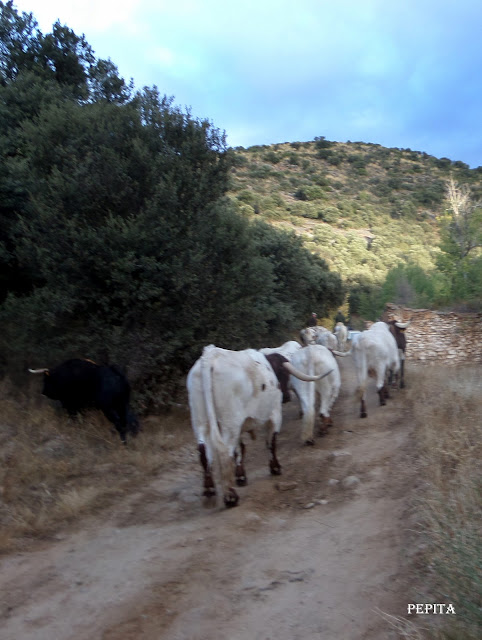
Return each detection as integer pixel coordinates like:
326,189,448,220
14,0,482,167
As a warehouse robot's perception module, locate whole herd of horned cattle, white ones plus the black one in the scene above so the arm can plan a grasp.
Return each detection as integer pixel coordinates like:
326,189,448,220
29,320,409,507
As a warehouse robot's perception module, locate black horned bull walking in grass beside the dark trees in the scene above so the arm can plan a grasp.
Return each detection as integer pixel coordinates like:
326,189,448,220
29,358,139,444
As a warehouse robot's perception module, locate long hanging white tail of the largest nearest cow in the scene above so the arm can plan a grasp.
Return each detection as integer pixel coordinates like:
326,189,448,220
201,344,233,500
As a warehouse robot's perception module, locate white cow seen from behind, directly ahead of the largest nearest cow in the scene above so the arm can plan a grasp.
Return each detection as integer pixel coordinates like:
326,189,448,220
290,344,340,444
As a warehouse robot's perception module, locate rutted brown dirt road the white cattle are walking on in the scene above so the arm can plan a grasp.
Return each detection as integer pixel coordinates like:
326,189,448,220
0,358,414,640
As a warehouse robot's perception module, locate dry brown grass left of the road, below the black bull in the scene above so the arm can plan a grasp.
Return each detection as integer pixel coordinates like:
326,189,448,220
0,381,193,553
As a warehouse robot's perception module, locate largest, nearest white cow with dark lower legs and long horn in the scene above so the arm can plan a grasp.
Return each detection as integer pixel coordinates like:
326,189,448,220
187,345,330,507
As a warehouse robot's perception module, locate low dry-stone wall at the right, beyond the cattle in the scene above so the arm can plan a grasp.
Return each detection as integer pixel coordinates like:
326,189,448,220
382,303,482,364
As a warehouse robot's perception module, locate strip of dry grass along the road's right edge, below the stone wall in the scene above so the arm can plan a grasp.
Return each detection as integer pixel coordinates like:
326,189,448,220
408,365,482,640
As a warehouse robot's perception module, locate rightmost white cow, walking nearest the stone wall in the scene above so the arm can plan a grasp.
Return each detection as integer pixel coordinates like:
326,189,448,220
335,322,400,418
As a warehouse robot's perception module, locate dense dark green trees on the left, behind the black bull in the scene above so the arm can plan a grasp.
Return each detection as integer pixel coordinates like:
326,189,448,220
0,2,344,407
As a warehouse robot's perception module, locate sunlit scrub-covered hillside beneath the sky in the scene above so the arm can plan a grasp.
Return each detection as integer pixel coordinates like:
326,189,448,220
230,138,482,308
